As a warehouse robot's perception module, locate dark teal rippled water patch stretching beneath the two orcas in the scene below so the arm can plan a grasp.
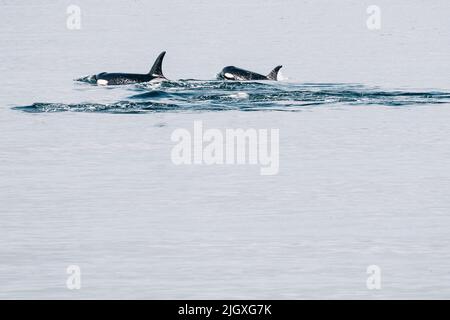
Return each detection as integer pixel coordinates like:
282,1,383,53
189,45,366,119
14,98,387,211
14,80,450,113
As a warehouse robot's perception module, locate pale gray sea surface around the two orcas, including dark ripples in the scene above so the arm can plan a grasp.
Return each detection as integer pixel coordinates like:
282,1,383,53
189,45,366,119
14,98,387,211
0,0,450,299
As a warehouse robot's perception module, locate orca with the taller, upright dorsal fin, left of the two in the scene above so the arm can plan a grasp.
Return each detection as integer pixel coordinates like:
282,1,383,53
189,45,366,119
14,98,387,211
94,51,166,86
